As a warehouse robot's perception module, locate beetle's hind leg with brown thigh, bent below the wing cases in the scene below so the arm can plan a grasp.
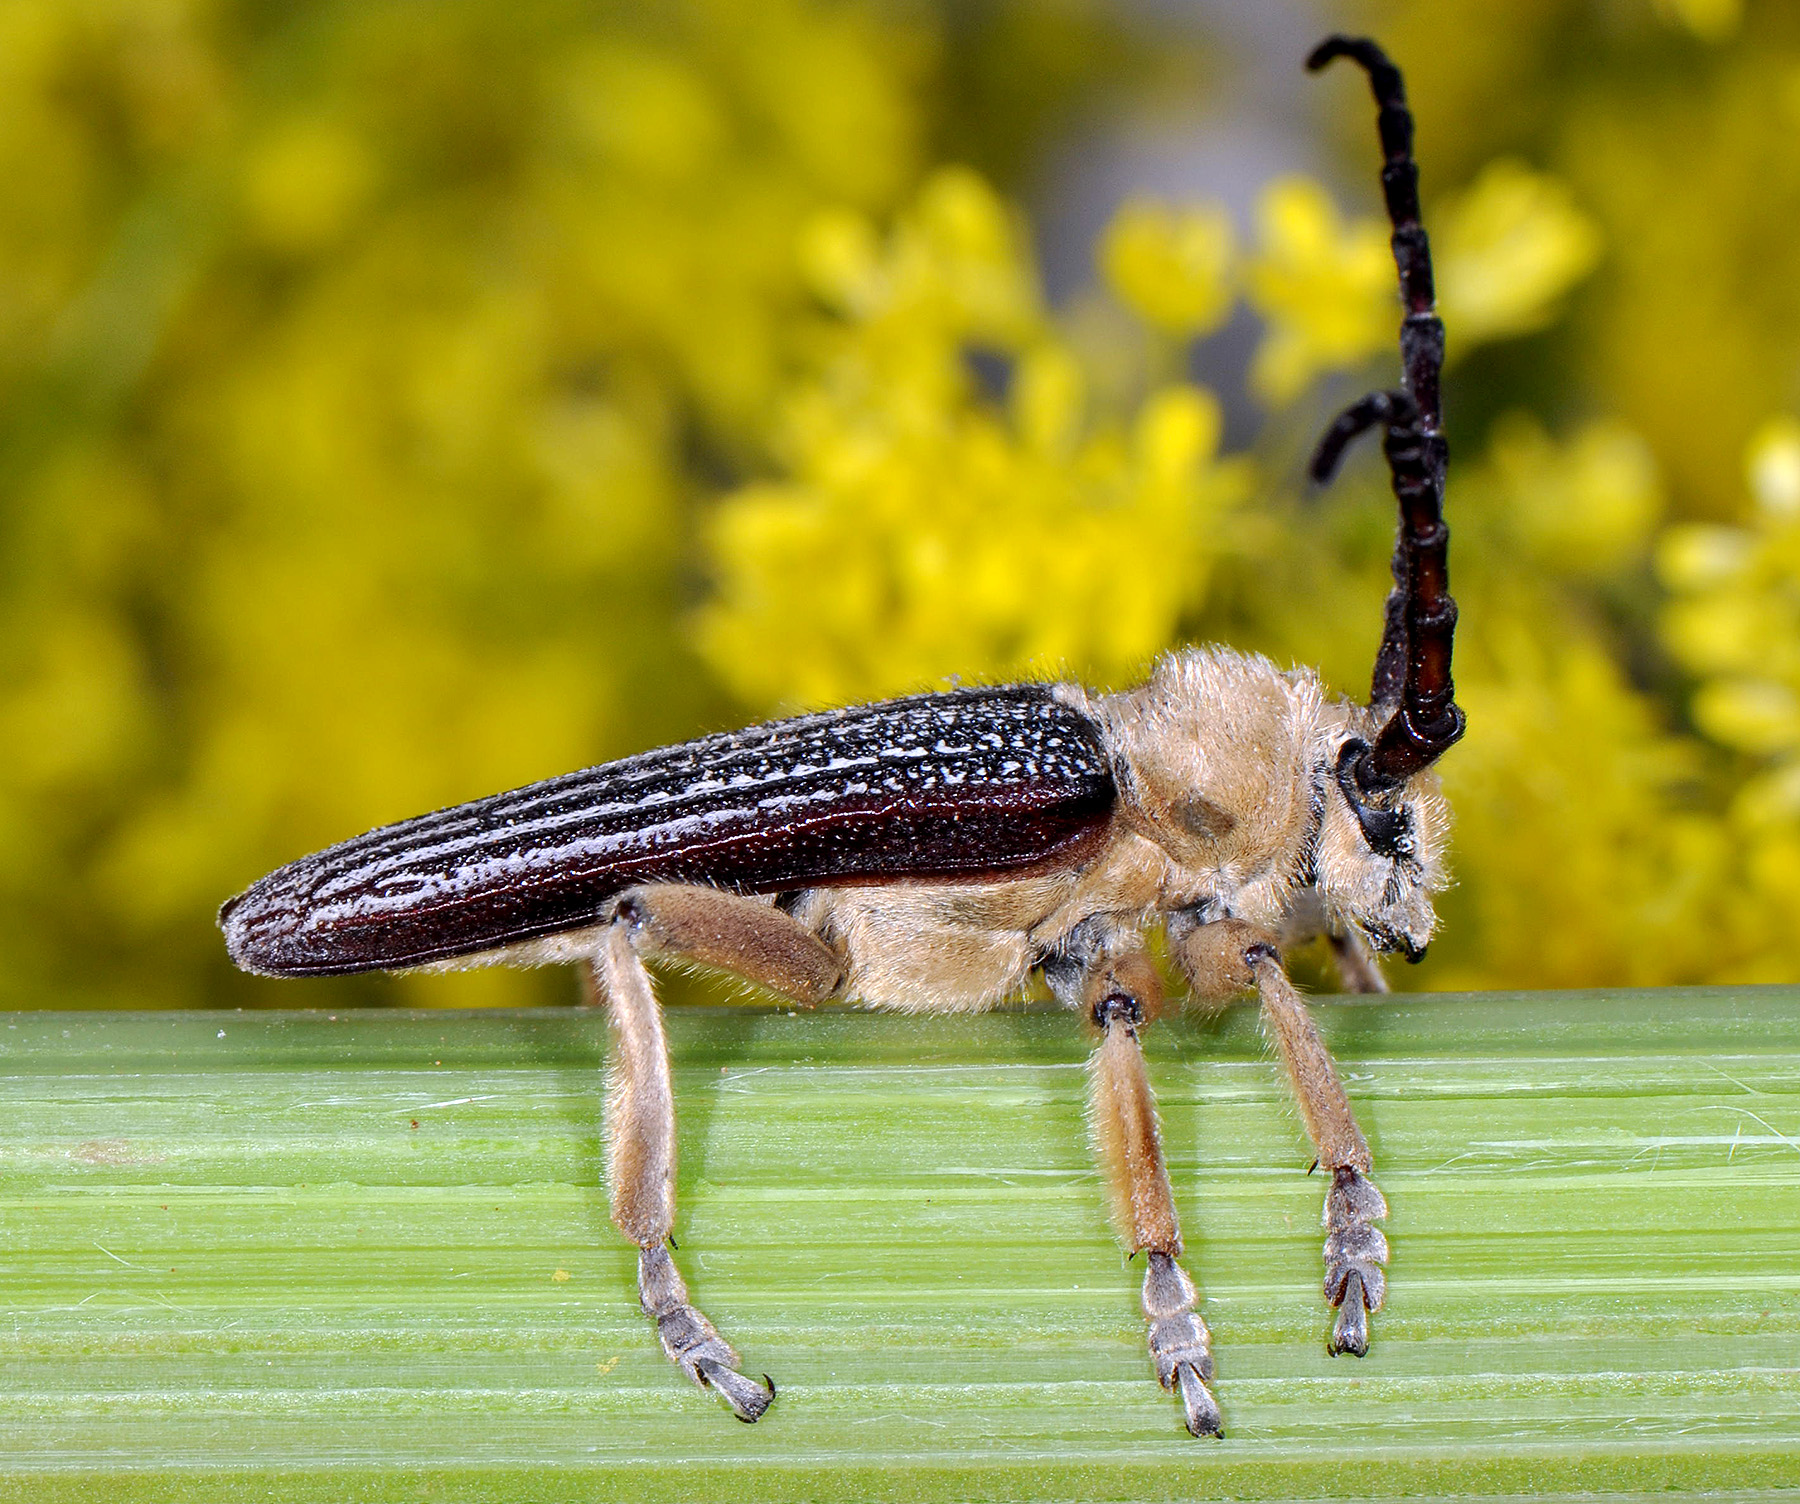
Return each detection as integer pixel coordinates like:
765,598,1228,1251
590,885,842,1421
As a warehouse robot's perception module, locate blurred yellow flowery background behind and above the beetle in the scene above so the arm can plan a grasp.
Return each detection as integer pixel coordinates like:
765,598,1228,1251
0,0,1800,1007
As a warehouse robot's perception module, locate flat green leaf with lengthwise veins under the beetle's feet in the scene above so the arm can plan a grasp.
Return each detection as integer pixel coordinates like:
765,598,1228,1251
0,988,1800,1504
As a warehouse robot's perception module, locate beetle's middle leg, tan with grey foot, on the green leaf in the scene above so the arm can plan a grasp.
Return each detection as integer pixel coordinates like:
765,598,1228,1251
1051,930,1224,1436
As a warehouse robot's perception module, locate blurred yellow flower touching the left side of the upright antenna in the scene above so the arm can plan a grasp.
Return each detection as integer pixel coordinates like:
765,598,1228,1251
1246,178,1400,405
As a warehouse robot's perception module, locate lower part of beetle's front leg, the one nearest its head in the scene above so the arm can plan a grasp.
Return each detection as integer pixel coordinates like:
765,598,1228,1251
1246,946,1388,1358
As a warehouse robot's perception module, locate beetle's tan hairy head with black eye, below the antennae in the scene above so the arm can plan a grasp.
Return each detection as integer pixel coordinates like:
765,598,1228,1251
1314,736,1449,961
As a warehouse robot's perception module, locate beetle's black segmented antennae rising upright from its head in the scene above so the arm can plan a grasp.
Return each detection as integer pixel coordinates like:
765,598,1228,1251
1307,36,1465,793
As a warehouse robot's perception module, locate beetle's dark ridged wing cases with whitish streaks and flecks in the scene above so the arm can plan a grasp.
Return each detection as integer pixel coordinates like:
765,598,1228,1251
220,685,1114,975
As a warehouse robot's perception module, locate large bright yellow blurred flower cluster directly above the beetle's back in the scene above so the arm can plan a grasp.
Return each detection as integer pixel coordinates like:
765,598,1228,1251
698,169,1249,707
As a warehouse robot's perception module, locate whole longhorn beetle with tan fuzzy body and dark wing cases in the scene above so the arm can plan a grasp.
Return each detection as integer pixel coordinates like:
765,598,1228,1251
220,36,1463,1436
